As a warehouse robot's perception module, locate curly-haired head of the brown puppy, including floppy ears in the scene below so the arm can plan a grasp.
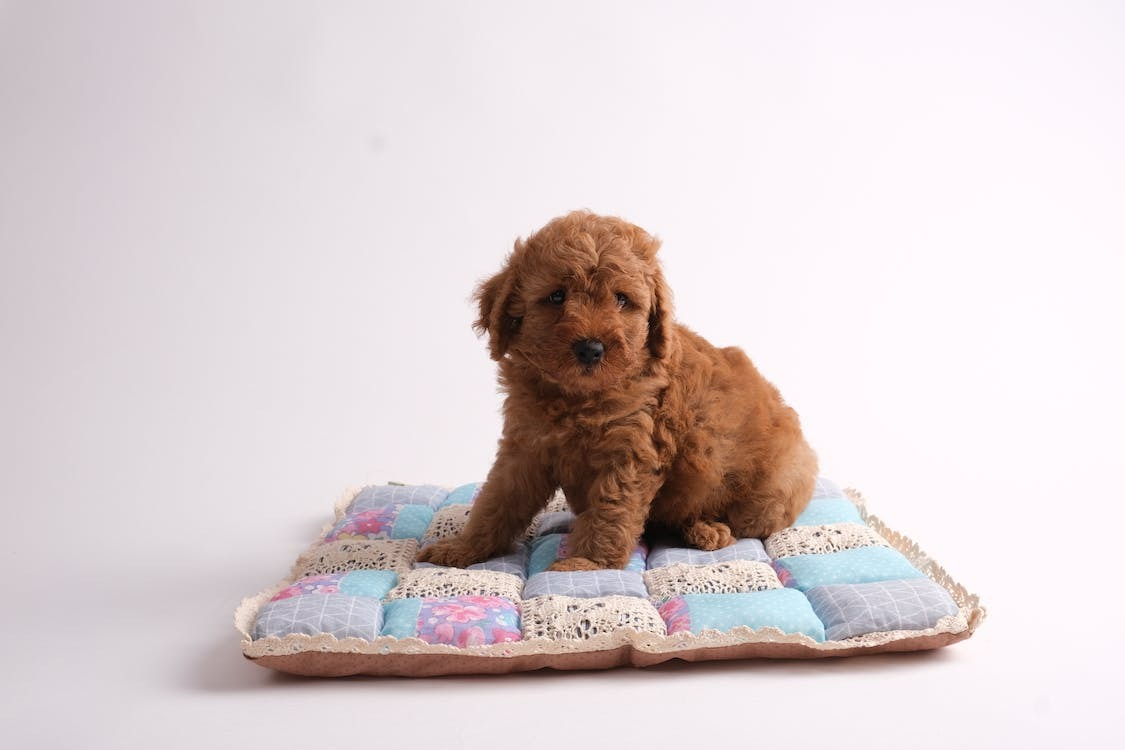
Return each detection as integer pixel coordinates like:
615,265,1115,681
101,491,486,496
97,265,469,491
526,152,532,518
475,211,673,394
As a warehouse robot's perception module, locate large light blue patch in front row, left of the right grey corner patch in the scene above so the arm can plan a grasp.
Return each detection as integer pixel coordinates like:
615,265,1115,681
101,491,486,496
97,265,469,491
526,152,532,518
683,588,825,641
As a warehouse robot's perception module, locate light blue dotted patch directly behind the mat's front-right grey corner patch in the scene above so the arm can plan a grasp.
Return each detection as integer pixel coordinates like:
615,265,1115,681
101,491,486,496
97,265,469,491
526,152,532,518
773,546,925,591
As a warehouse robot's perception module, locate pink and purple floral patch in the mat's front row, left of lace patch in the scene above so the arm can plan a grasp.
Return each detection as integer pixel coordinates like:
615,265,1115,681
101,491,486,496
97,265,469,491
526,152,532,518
417,596,521,648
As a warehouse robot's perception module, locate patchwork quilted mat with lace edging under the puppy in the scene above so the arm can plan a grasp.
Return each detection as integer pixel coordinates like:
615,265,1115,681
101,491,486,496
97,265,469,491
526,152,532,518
235,479,984,676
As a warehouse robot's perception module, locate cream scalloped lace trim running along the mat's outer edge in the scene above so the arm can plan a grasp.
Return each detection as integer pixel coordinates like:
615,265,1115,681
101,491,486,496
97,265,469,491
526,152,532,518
234,488,987,659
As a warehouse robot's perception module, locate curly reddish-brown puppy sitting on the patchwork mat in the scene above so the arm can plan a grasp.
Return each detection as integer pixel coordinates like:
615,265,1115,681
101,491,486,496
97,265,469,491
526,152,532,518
419,211,817,570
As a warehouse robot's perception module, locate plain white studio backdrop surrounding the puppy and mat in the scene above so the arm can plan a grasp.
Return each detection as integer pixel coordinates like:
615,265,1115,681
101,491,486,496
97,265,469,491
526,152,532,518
0,1,1125,748
